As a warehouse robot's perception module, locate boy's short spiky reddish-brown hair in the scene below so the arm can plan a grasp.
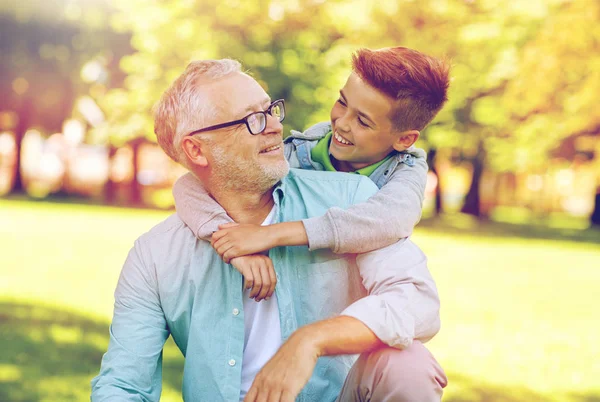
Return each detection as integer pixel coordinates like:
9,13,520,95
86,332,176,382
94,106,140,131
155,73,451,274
352,47,450,131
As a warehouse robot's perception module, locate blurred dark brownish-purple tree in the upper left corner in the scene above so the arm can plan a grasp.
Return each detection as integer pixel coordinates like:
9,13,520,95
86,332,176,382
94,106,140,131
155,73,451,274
0,0,129,191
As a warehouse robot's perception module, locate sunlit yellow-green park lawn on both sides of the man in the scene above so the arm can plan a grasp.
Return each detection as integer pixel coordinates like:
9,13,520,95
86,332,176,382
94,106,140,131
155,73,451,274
0,200,600,402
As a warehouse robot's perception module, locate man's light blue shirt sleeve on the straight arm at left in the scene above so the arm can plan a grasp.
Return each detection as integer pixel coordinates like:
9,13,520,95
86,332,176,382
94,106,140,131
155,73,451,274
91,240,169,402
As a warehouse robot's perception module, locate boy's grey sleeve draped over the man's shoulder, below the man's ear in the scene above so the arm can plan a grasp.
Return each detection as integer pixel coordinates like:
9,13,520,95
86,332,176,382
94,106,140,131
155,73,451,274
173,173,233,241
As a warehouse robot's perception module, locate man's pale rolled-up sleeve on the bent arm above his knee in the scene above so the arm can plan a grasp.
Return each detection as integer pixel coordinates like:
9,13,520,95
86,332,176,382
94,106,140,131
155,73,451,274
342,239,440,349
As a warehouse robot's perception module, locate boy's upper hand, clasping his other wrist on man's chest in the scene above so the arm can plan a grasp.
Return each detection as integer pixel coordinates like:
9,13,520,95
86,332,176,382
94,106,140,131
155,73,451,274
211,223,274,263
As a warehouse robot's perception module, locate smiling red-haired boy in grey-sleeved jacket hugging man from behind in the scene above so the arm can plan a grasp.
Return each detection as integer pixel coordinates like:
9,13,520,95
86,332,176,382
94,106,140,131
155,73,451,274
173,47,449,300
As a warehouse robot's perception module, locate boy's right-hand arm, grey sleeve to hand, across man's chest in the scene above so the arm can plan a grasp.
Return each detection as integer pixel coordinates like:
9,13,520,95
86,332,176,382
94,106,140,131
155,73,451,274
213,151,428,262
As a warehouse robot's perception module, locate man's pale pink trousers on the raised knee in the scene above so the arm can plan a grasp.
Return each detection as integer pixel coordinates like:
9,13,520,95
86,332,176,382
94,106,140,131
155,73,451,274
338,341,448,402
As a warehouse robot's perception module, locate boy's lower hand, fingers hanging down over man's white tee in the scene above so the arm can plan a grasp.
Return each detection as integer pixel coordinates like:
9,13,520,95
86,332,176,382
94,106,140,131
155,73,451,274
231,254,277,302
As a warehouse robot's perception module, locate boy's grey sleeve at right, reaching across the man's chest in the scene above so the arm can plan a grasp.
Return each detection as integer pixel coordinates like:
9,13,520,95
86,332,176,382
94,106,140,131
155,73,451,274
302,152,428,253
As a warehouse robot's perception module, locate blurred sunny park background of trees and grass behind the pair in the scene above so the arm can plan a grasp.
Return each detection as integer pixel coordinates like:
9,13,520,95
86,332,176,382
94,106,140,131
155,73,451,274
0,0,600,402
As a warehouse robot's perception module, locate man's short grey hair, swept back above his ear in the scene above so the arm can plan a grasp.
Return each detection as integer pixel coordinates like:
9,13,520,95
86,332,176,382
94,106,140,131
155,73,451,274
154,59,241,167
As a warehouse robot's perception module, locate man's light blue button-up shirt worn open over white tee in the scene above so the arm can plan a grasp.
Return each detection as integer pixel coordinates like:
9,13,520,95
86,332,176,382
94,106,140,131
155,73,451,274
92,169,439,402
